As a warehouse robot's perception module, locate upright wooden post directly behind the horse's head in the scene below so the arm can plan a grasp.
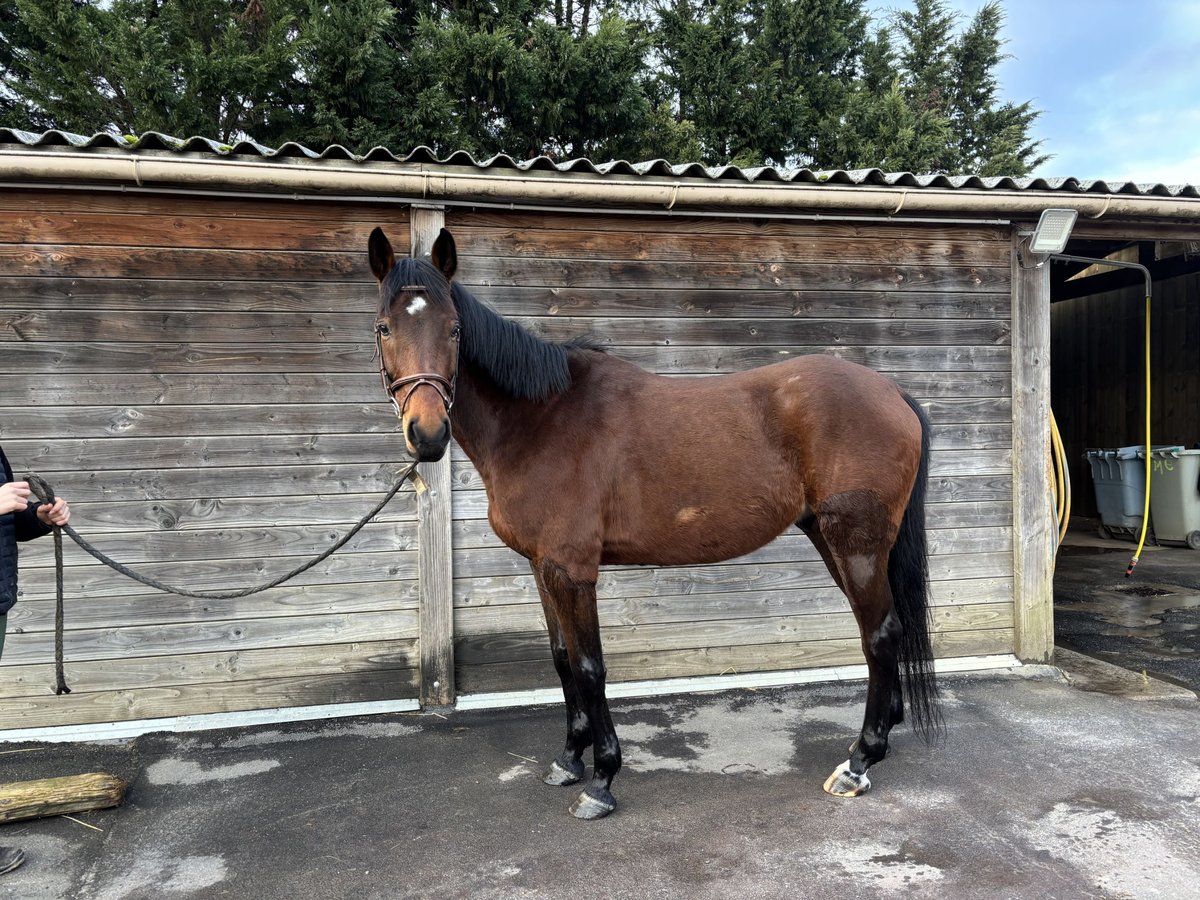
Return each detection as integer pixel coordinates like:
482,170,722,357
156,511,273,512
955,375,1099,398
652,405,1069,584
409,205,455,707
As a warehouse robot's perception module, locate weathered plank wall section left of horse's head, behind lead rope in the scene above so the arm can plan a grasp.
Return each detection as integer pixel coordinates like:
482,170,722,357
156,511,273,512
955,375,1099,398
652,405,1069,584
0,191,418,730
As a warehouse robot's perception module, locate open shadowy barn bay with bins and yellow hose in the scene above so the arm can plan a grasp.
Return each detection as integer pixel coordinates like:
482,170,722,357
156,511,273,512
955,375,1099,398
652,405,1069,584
1050,230,1200,691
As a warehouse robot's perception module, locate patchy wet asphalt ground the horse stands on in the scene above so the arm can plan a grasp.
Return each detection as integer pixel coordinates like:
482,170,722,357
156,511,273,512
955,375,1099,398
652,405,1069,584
0,520,1200,900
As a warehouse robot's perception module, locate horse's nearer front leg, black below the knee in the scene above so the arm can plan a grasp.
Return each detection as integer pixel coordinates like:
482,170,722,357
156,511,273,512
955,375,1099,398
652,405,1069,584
539,563,620,818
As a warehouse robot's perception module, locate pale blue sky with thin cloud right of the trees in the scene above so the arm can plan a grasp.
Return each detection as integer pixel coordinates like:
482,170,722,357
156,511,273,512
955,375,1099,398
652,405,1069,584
869,0,1200,185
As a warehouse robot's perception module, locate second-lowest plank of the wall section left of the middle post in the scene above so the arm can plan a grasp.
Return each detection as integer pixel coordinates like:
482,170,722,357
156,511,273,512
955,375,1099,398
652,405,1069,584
0,638,420,701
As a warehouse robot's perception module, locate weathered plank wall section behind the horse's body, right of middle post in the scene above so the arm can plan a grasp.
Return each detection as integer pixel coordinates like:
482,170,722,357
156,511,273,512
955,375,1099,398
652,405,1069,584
446,210,1014,694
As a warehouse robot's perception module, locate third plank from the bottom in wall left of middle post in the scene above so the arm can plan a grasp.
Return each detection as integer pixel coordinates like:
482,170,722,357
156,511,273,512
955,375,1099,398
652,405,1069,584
4,610,416,666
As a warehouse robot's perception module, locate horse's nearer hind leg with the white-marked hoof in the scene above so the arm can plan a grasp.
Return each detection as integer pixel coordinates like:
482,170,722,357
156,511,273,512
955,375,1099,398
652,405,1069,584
805,491,904,797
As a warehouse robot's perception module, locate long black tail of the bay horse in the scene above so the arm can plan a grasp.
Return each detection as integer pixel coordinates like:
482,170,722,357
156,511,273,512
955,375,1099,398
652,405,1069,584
888,394,942,738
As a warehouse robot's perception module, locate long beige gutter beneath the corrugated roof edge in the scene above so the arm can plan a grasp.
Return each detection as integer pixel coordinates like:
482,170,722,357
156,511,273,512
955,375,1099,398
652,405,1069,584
7,149,1200,222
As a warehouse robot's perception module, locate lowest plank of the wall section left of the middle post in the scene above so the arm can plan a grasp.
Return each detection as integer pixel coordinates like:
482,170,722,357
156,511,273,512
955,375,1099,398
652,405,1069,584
0,668,416,731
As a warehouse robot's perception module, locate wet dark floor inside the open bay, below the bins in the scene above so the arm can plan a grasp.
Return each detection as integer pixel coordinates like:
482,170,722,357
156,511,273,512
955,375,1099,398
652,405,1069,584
1055,520,1200,691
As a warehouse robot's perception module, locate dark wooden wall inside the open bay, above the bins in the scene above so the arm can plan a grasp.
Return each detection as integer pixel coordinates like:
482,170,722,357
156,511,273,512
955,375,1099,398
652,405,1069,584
1050,275,1200,517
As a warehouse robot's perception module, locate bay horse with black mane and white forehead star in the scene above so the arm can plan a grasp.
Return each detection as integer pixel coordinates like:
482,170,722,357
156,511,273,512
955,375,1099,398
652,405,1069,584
367,228,941,818
